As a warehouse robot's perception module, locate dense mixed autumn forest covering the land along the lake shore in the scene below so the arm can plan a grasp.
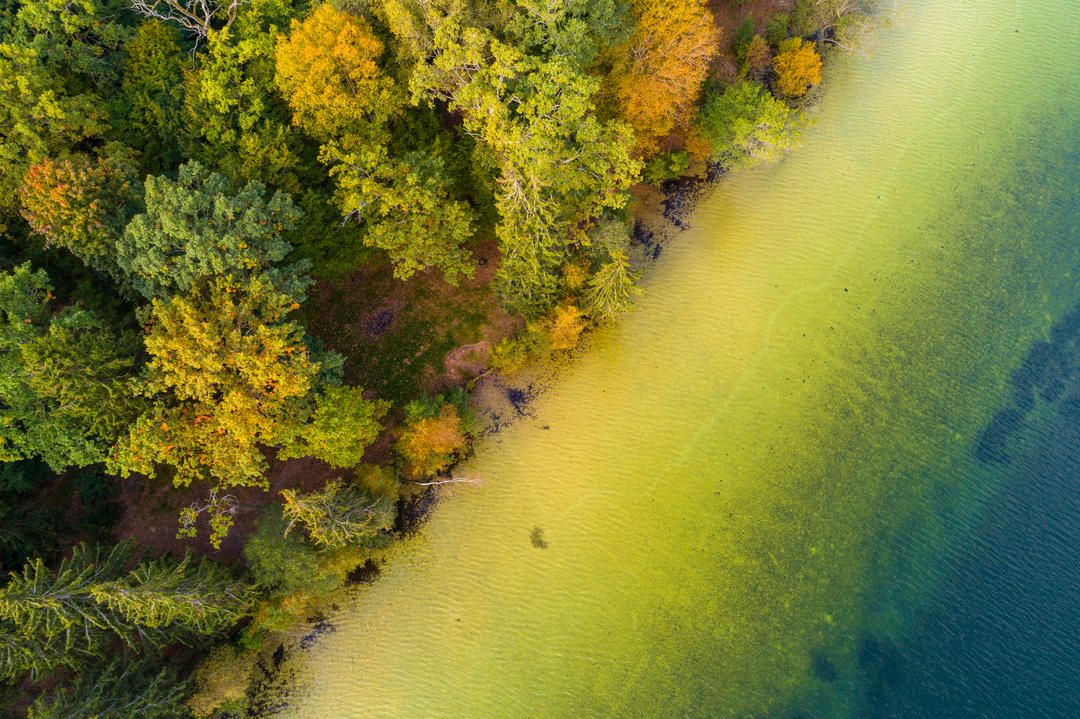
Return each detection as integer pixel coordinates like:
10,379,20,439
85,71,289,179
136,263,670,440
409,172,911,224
0,0,880,719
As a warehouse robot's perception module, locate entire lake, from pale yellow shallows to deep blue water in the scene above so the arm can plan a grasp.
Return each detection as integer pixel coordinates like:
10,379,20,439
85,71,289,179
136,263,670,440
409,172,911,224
263,0,1080,719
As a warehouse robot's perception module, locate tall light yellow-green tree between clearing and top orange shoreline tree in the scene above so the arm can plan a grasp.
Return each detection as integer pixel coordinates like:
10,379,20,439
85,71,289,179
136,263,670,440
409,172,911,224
415,31,640,314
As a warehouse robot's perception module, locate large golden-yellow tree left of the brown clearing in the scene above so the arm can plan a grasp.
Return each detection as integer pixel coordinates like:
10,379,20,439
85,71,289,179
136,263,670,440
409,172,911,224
110,274,319,496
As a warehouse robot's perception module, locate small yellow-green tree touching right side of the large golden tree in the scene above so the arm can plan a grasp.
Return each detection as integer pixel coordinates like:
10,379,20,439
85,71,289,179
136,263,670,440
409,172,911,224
278,385,390,469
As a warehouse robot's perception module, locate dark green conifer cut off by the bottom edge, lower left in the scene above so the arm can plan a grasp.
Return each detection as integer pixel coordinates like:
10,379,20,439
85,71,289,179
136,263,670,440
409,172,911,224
28,659,190,719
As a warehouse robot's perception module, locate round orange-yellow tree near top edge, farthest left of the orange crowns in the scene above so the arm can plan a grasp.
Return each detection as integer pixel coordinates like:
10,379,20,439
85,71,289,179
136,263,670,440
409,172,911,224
274,3,404,146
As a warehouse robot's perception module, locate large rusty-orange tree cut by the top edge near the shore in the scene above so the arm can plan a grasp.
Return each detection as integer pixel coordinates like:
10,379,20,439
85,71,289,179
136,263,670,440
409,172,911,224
610,0,719,154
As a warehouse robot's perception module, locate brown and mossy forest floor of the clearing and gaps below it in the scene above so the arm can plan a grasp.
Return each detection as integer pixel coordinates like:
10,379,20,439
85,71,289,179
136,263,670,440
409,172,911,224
113,241,523,561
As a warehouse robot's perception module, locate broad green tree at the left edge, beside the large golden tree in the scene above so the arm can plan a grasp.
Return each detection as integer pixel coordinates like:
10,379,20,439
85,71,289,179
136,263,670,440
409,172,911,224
0,264,141,472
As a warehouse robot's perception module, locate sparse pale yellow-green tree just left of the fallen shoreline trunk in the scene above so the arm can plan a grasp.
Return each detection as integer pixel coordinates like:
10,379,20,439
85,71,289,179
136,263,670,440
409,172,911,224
281,479,397,548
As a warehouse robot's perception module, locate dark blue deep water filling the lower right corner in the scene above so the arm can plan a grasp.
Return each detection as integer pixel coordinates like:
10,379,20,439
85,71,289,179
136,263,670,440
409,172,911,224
861,300,1080,719
